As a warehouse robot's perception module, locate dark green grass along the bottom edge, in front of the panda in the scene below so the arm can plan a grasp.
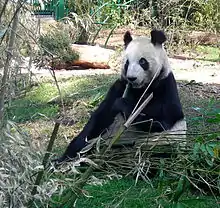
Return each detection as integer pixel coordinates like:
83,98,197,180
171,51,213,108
51,178,219,208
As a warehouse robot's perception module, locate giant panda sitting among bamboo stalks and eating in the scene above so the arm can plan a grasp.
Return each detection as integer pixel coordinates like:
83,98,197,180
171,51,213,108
57,29,186,162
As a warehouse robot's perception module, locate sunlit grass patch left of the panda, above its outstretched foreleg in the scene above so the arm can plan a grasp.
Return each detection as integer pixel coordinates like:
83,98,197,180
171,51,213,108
6,76,115,123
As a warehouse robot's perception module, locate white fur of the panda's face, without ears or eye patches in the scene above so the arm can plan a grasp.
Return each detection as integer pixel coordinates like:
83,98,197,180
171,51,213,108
121,37,171,88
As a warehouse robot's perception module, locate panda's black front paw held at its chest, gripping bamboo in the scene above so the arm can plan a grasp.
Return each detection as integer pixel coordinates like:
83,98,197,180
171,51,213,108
113,98,134,118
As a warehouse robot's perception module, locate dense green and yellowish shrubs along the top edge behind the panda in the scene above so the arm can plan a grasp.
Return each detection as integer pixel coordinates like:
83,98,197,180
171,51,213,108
62,0,220,31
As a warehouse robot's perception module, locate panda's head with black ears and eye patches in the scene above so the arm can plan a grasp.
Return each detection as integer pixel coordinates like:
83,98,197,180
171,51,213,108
122,30,170,88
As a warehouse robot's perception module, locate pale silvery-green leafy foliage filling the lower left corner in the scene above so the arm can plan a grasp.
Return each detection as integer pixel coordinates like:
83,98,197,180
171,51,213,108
0,122,42,207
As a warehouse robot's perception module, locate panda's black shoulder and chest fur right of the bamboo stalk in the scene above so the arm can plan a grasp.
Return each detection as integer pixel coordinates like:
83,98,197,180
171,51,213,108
124,72,184,132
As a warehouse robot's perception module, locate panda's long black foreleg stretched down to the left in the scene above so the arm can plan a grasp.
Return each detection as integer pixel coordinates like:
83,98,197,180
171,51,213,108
57,79,126,163
